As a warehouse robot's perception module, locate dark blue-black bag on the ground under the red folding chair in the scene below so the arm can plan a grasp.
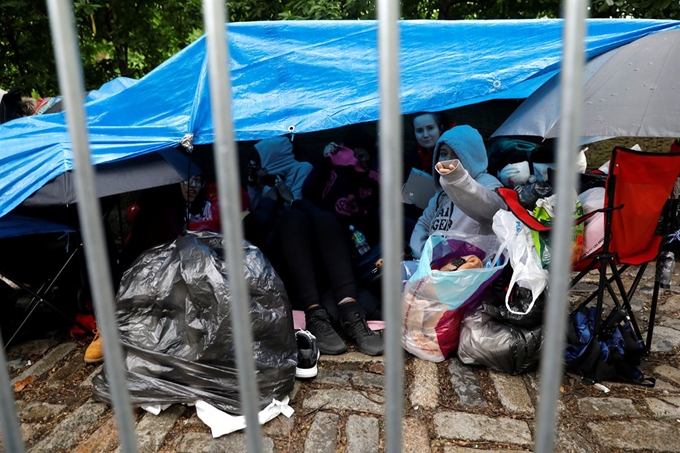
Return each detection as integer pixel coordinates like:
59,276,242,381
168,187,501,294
565,307,655,387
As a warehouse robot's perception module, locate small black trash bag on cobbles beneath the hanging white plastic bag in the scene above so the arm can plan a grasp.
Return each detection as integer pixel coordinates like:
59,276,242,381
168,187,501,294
458,294,543,375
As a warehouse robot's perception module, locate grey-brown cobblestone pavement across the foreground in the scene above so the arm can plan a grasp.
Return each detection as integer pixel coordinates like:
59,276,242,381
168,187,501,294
0,266,680,453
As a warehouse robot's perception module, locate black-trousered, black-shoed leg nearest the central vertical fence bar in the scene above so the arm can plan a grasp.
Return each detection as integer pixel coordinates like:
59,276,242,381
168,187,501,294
312,210,384,355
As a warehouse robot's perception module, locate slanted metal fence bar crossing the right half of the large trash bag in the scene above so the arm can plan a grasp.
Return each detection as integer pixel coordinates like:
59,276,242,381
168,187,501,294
203,0,262,452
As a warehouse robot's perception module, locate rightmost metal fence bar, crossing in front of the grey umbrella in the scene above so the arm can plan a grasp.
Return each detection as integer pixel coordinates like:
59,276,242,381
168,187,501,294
534,0,588,453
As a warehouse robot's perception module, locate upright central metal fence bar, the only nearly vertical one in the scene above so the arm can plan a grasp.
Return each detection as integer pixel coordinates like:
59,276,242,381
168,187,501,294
377,0,404,453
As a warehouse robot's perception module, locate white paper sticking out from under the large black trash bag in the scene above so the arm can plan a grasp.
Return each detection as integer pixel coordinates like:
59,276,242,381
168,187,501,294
196,397,295,438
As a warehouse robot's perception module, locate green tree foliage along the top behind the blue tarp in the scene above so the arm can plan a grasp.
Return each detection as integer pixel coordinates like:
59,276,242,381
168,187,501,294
0,0,680,97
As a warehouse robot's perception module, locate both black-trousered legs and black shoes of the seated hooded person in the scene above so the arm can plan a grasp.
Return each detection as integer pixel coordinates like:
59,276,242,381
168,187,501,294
243,175,384,355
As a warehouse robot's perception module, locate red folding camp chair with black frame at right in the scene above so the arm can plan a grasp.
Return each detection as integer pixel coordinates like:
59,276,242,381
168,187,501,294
498,147,680,352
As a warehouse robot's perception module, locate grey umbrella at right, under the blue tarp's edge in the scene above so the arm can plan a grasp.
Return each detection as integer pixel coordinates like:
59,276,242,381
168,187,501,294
492,29,680,143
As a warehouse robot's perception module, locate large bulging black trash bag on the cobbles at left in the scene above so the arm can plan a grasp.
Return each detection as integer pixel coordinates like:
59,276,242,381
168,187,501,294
92,232,297,415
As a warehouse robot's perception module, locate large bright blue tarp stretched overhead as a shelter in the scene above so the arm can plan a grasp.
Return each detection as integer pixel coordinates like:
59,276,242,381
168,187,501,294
0,19,680,216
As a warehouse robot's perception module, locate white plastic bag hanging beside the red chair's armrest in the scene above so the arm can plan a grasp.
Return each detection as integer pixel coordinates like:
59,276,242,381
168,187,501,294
493,210,548,315
